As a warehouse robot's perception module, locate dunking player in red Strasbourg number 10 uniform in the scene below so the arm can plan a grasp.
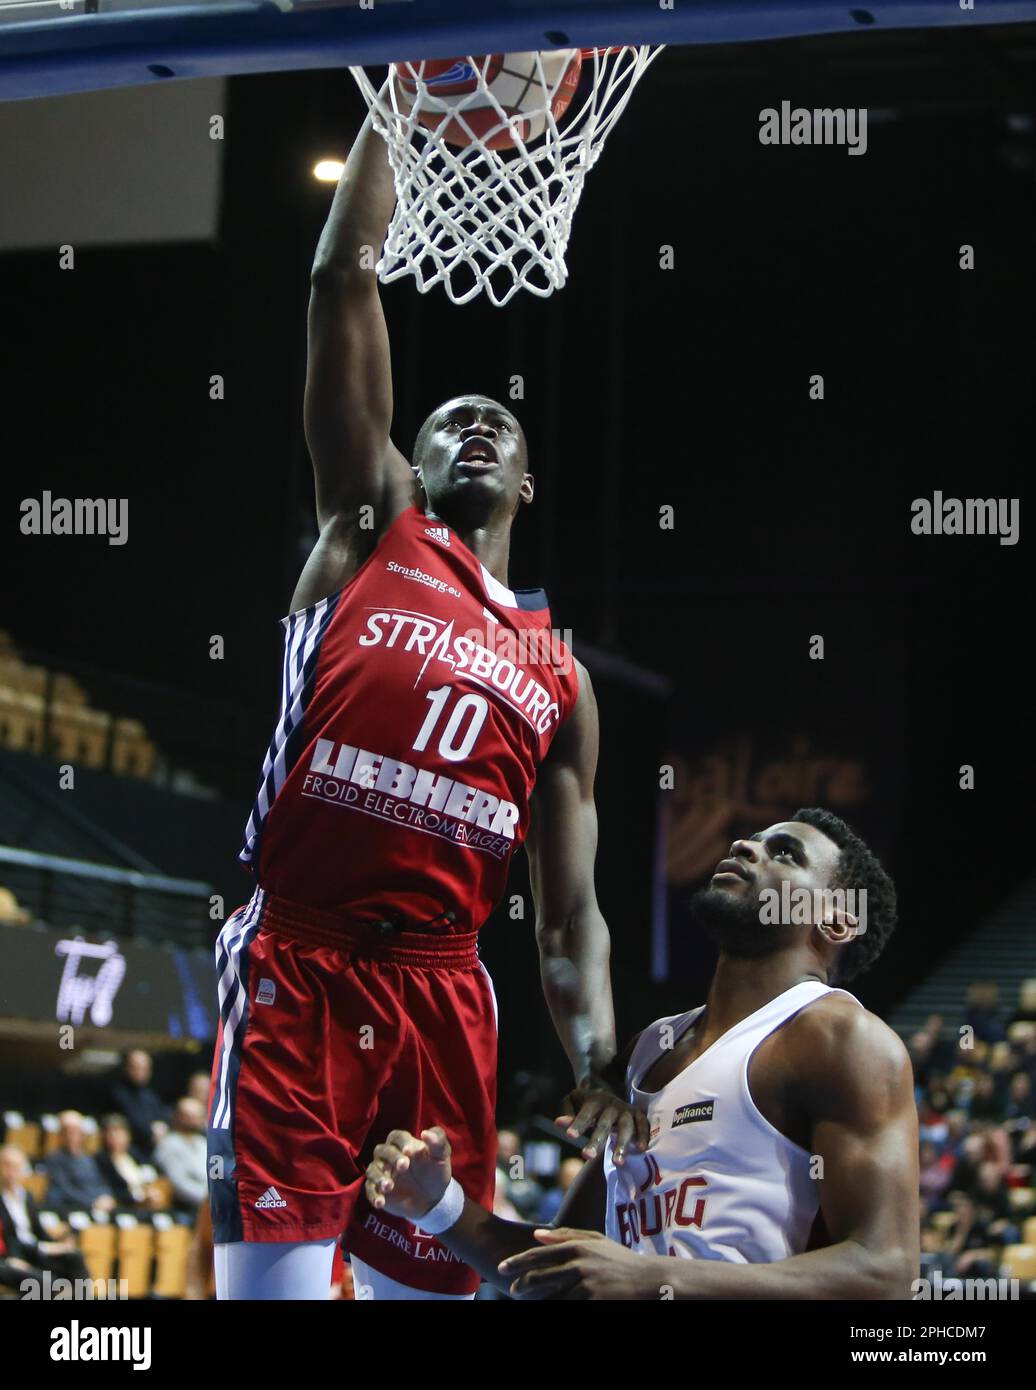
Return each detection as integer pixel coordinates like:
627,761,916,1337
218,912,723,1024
209,111,647,1298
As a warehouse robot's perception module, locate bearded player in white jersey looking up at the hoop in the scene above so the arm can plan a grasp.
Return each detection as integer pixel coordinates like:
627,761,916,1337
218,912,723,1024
366,809,919,1298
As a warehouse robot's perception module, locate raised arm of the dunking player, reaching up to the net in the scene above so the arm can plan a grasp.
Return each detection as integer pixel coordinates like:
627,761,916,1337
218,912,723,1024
295,108,413,606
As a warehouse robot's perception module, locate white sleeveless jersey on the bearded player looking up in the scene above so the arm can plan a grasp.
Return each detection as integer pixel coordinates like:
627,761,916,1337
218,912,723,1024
605,980,862,1264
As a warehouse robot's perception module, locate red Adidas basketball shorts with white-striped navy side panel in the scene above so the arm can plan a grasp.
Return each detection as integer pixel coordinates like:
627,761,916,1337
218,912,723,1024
209,888,496,1294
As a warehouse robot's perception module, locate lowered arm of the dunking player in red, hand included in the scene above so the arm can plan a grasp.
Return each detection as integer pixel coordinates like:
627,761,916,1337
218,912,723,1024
526,663,648,1161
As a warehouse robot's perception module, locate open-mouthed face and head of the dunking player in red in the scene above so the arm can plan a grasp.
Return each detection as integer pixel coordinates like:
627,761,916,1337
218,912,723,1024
419,396,533,514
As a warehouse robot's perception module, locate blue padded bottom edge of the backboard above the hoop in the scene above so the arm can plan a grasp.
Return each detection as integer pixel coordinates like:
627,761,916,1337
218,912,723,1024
0,0,1036,100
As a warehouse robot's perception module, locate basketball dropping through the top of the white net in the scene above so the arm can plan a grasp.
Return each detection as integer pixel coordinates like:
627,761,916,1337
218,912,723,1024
392,49,583,150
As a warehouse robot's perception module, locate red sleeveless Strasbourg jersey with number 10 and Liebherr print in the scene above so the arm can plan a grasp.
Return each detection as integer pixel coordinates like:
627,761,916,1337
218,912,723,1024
241,507,578,931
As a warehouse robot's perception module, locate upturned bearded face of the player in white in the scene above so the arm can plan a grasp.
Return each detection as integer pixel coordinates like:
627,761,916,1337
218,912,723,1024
694,820,840,955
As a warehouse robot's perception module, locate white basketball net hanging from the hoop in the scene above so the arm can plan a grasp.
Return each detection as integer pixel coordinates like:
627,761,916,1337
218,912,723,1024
349,44,662,304
